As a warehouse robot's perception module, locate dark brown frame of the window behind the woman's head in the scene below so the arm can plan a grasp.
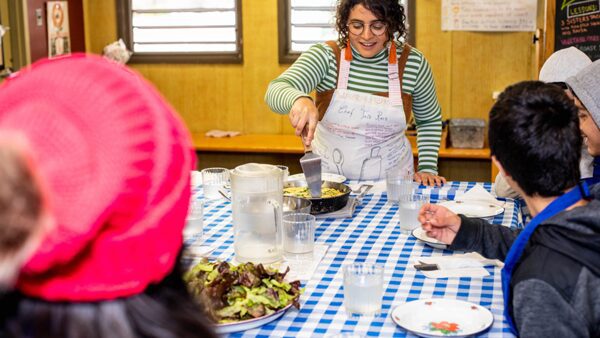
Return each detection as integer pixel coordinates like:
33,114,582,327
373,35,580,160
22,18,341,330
277,0,416,64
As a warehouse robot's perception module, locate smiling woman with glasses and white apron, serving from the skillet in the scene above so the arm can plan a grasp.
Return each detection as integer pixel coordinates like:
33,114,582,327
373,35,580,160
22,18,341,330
265,0,445,185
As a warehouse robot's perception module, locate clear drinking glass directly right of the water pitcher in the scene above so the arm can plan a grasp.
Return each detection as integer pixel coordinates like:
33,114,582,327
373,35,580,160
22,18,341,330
283,213,315,254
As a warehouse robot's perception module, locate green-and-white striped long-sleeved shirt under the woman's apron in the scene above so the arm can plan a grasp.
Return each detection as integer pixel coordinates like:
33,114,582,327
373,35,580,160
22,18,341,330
265,43,442,174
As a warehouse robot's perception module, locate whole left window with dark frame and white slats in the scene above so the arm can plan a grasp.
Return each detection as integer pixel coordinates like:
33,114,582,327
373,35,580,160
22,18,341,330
117,0,242,63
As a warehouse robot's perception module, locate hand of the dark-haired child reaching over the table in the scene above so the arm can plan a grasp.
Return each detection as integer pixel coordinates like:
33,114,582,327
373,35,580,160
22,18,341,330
418,204,461,244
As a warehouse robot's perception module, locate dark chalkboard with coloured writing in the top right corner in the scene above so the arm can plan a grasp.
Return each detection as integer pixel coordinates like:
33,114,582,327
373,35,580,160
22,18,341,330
554,0,600,60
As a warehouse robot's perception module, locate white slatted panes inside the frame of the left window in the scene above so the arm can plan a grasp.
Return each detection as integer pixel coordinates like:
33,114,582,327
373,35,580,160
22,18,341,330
131,0,239,53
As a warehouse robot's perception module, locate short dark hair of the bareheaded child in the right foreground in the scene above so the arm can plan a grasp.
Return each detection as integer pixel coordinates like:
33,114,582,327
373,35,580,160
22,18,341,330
489,81,581,197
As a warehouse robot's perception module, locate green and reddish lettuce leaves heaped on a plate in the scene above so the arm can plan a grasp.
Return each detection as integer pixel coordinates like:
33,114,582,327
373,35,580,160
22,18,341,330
183,258,301,324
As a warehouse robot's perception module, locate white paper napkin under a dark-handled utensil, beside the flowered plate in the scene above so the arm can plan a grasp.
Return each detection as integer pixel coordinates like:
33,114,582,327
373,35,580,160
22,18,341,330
412,252,504,278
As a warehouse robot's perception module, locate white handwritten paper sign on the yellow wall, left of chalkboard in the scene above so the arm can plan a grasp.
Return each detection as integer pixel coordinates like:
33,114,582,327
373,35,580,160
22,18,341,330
442,0,537,32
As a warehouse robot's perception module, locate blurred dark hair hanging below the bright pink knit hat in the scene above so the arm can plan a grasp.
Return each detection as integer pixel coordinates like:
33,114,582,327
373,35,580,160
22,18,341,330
0,254,216,338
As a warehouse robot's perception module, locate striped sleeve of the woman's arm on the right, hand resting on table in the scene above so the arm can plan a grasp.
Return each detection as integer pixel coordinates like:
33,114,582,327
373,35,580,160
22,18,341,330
410,52,442,175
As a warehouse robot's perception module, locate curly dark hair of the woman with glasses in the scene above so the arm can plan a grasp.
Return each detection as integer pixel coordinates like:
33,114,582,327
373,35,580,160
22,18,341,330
335,0,406,47
